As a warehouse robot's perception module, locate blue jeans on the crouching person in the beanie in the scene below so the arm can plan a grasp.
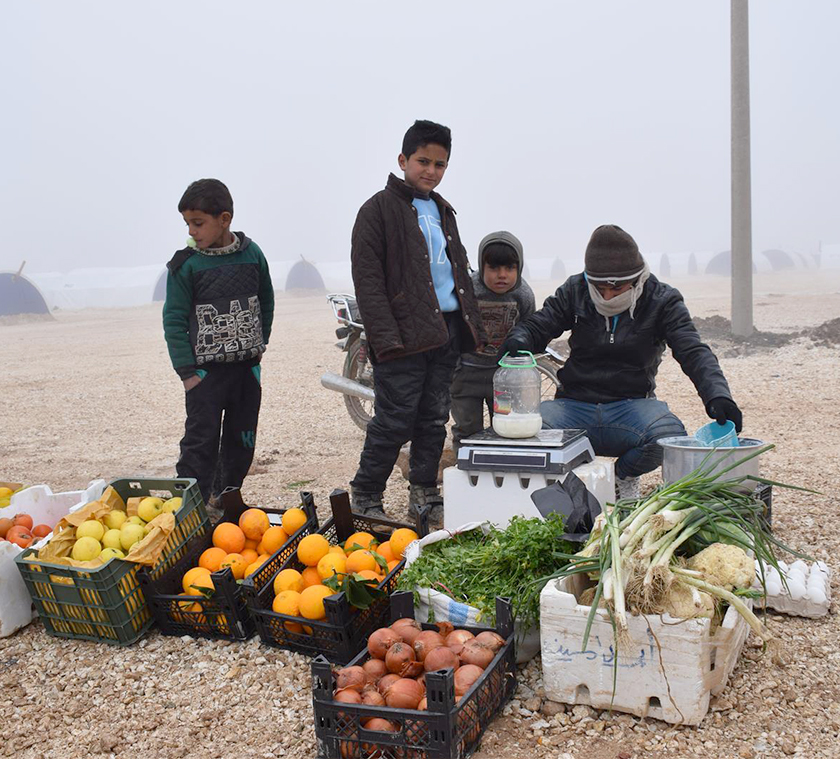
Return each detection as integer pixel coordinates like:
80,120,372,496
540,398,685,478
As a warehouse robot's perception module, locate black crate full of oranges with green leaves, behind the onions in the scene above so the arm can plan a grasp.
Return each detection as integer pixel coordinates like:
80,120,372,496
243,490,428,663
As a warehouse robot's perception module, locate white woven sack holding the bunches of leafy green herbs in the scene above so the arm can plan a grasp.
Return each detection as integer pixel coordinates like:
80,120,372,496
405,522,540,664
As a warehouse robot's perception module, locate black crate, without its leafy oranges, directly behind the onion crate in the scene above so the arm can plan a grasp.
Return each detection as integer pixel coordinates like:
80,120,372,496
242,490,428,664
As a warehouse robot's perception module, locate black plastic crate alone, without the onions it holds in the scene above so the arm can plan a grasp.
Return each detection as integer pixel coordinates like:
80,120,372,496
312,591,516,759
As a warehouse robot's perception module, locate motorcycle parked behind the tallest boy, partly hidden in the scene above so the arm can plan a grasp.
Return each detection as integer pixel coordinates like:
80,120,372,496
321,293,566,429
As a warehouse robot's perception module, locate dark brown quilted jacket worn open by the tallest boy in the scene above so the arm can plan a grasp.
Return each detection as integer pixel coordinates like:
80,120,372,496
350,174,485,361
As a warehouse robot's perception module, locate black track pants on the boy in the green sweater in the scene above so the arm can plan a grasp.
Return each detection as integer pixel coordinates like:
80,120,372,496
176,364,262,503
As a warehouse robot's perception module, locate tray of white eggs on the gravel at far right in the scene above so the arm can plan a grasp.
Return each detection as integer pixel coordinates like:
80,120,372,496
752,559,831,619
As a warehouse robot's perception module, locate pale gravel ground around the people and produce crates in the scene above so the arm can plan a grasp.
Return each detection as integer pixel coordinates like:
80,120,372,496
0,273,840,759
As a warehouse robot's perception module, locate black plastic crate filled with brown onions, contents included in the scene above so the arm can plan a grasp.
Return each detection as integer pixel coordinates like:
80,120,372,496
312,592,516,759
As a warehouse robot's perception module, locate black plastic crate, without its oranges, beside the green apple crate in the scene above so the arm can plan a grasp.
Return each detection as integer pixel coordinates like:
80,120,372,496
139,488,318,640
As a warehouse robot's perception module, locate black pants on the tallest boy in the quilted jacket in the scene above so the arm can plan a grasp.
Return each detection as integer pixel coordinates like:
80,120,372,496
351,324,459,493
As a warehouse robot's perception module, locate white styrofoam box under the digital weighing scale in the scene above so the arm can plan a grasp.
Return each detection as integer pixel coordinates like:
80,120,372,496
443,456,615,530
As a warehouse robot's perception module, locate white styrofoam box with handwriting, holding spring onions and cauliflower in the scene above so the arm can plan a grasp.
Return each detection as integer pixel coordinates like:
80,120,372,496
540,576,749,725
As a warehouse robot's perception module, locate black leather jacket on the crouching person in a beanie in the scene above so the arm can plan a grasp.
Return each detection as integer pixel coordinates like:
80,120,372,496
510,274,732,411
